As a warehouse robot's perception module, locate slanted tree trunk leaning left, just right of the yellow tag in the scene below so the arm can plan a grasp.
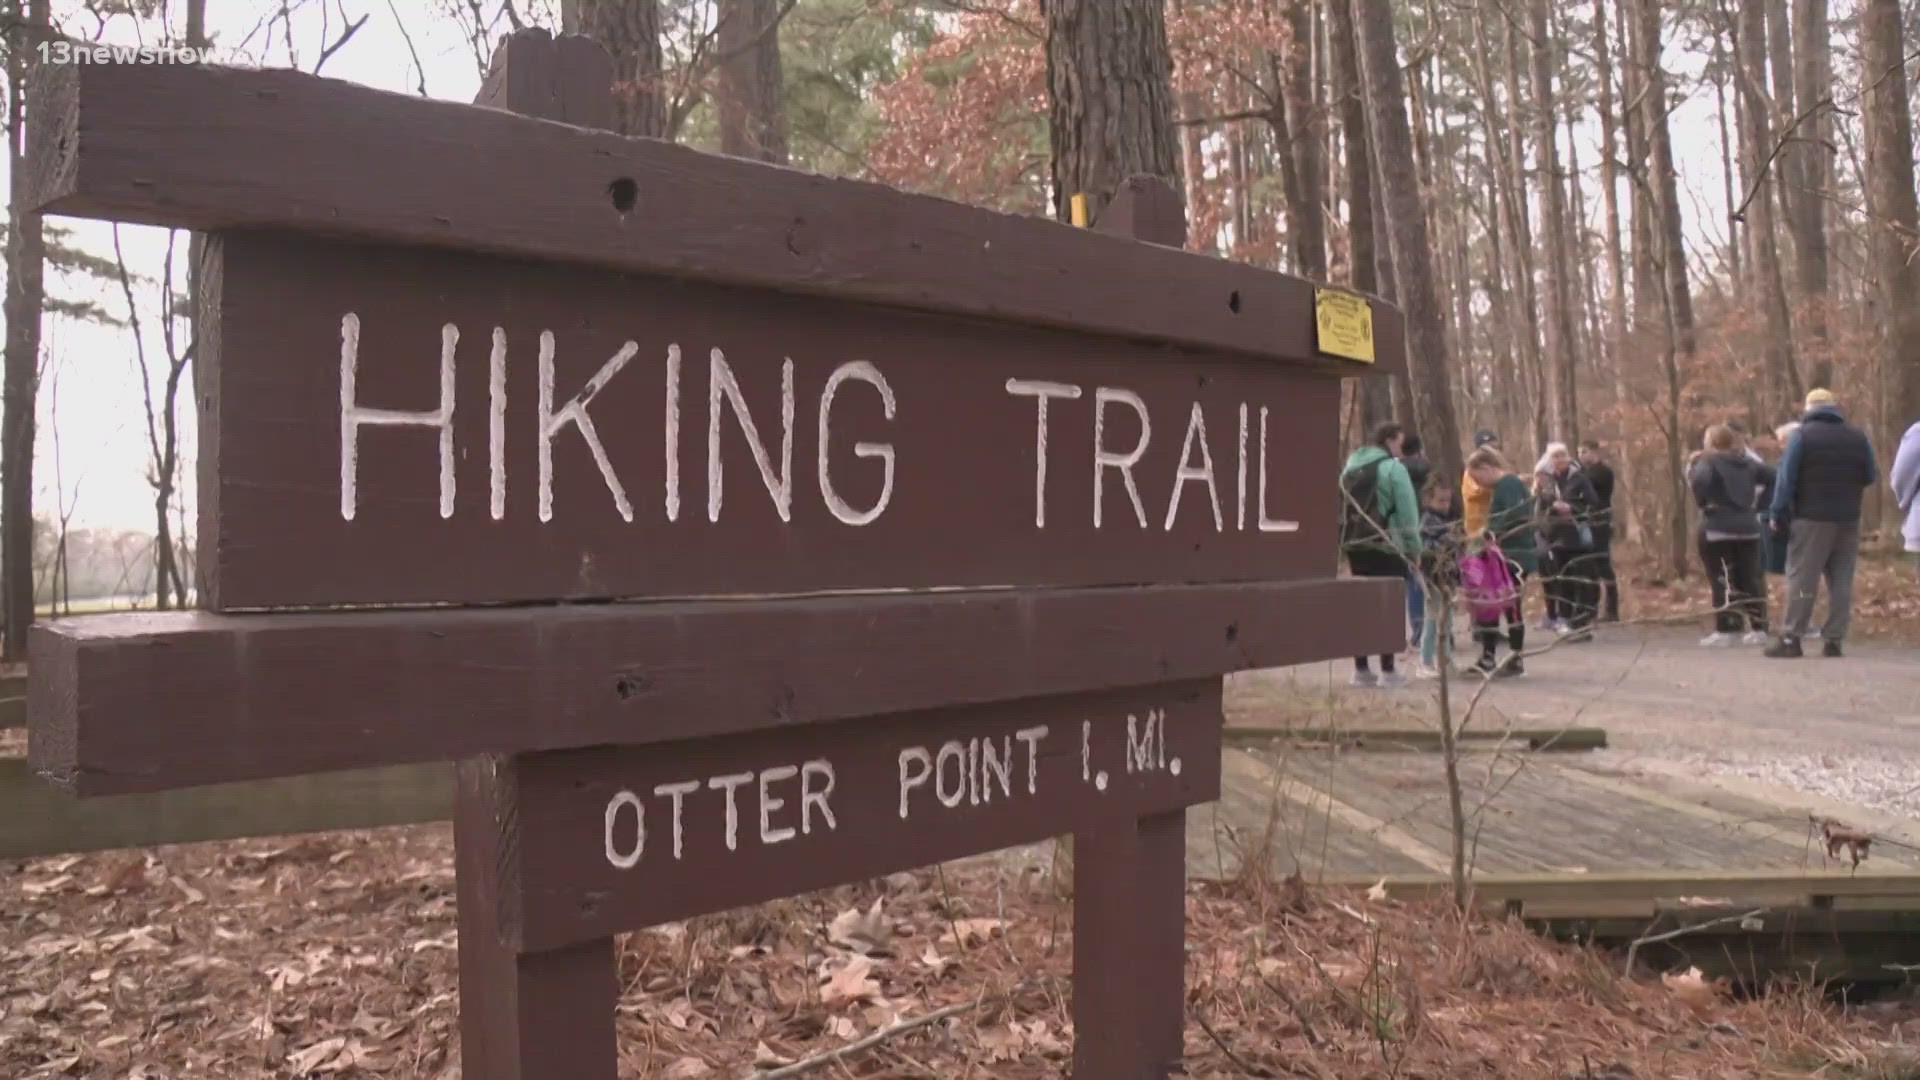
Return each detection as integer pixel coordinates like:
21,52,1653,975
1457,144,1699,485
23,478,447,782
1354,0,1463,475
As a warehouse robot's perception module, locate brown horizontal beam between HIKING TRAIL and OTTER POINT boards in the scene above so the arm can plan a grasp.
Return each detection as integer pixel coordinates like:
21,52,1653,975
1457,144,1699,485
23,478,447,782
29,578,1402,794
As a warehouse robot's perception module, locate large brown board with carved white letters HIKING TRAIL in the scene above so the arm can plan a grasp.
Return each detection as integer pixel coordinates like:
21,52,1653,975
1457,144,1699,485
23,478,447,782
200,234,1340,609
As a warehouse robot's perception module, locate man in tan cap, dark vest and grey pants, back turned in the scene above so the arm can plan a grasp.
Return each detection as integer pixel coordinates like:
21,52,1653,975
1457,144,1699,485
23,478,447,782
1766,390,1880,659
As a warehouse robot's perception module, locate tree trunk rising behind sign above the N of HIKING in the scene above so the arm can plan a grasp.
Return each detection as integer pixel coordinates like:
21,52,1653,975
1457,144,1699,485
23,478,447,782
714,0,787,165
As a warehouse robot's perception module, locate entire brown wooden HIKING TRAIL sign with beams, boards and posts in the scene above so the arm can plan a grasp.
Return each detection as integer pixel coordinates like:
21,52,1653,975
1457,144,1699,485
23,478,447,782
23,31,1404,1080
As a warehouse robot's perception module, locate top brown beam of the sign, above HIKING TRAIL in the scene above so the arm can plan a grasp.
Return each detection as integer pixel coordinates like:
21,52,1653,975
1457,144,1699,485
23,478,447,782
21,63,1405,375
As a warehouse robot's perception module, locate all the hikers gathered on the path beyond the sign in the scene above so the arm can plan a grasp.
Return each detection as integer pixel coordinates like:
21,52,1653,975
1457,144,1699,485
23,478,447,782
1340,390,1920,686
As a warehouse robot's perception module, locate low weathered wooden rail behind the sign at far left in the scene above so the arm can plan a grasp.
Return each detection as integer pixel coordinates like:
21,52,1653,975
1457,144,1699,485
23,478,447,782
0,757,453,859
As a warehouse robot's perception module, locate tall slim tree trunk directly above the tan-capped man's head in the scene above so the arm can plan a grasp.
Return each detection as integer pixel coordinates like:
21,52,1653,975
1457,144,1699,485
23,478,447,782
1791,0,1834,386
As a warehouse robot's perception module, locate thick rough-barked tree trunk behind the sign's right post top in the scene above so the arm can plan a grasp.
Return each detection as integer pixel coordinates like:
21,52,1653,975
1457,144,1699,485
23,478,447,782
1043,0,1181,221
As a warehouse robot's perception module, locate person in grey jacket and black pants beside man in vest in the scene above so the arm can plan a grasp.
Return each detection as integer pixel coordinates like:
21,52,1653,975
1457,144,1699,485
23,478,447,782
1688,425,1774,648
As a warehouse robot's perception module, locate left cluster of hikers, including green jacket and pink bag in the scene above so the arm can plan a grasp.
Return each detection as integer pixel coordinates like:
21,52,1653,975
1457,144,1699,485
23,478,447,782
1340,423,1620,686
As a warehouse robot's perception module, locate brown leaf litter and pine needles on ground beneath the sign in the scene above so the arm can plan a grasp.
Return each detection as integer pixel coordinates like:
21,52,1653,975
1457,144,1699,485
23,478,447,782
0,826,1907,1080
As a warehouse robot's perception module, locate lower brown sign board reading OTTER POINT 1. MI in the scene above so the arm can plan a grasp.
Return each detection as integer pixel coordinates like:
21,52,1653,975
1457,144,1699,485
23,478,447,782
495,678,1221,951
